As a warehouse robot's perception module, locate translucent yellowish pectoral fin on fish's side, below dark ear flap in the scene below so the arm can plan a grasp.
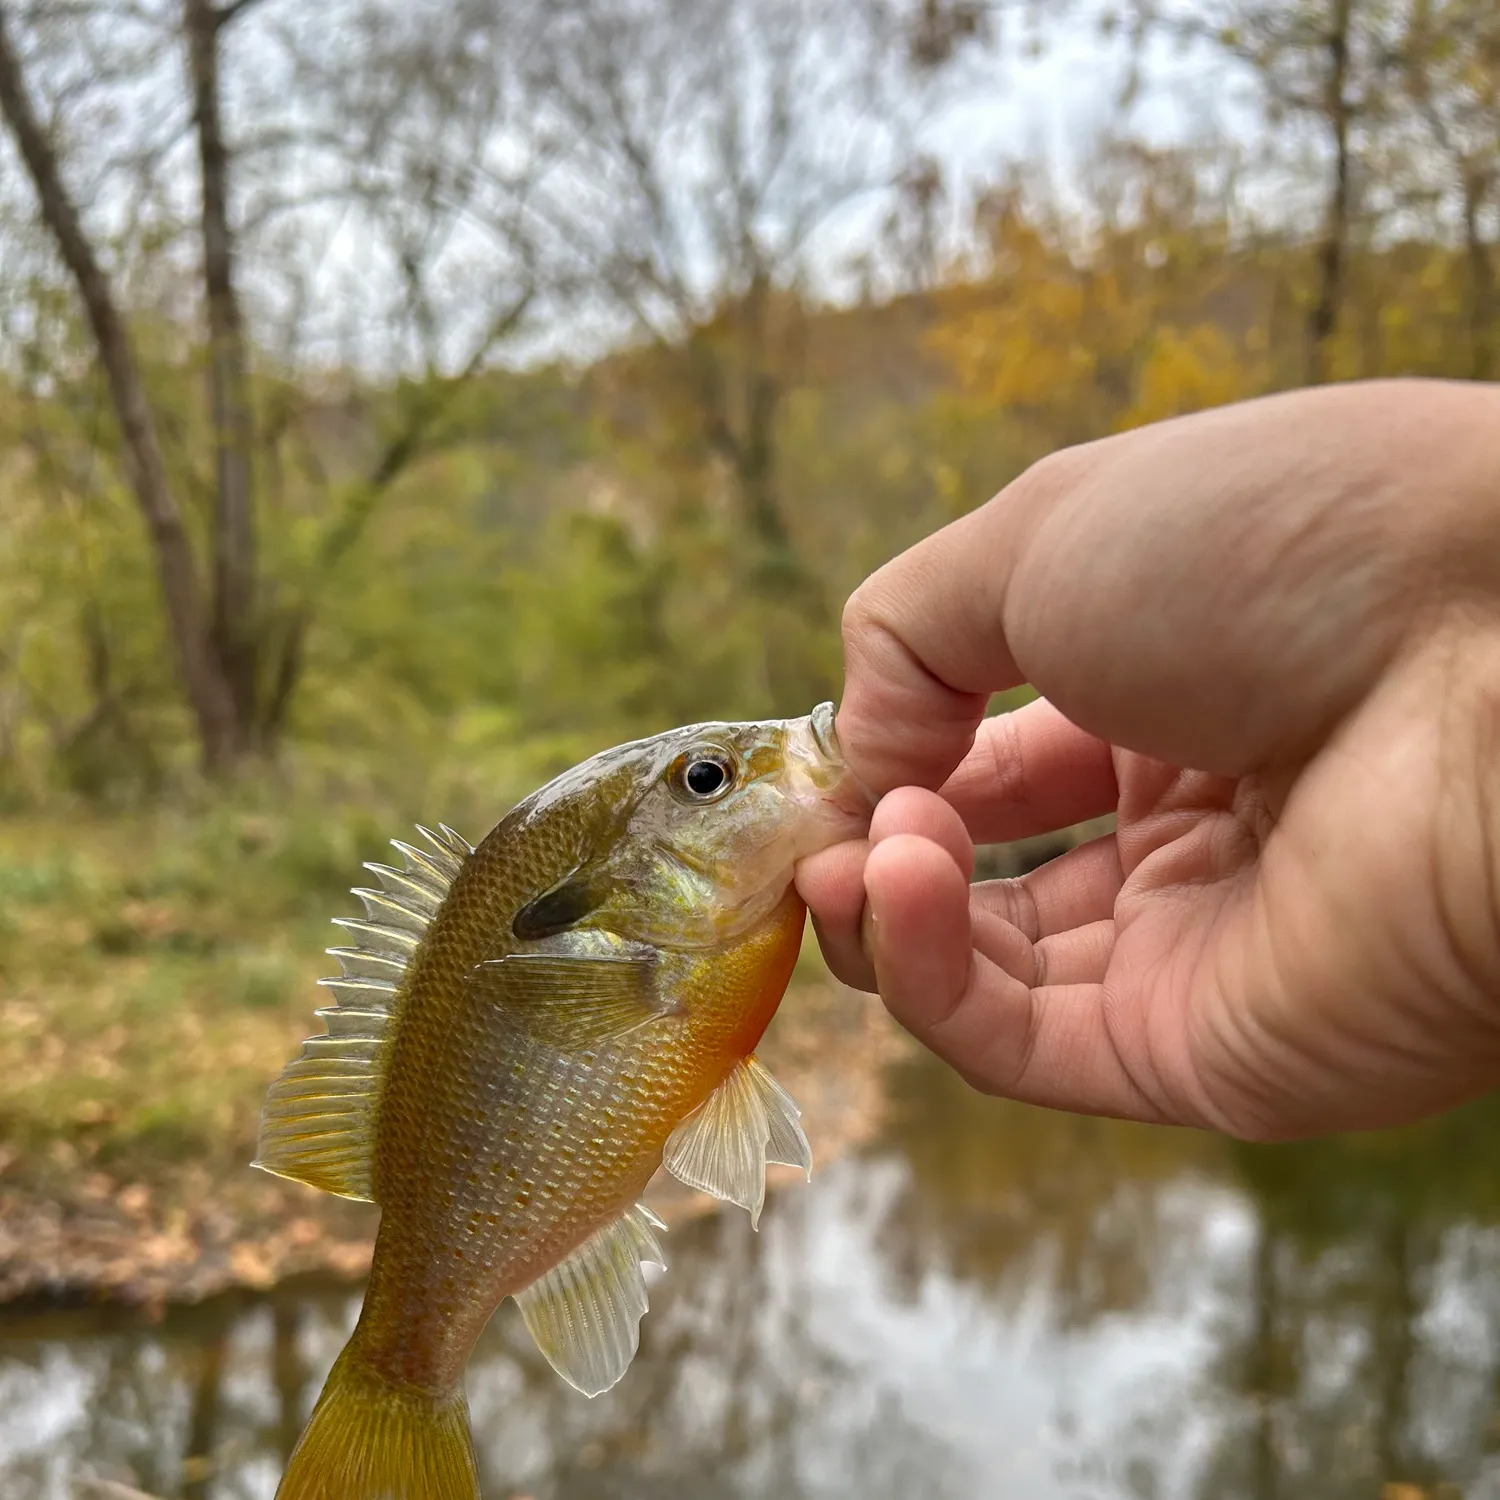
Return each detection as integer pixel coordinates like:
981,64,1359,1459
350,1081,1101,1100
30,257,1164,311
470,953,675,1050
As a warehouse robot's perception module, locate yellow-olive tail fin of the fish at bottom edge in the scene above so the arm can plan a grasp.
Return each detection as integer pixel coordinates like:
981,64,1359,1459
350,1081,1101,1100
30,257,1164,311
276,1347,480,1500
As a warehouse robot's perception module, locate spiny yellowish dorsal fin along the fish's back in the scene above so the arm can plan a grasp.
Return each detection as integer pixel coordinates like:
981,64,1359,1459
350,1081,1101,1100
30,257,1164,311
254,824,474,1200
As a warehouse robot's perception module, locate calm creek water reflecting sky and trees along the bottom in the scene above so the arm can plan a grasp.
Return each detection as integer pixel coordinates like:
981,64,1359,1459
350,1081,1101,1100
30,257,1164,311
0,1059,1500,1500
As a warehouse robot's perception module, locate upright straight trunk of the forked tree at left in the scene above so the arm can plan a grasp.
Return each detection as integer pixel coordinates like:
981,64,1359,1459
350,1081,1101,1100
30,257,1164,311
183,0,258,750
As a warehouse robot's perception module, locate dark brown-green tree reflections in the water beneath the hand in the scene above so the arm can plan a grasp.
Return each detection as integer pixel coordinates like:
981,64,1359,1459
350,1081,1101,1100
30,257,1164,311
875,1059,1500,1500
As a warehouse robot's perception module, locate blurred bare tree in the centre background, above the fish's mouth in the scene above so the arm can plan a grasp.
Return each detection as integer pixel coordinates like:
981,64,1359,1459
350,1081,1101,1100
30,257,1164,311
516,0,954,711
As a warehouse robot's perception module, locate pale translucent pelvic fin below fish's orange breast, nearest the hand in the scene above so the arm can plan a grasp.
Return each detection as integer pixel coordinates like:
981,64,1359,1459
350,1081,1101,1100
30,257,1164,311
662,1058,813,1229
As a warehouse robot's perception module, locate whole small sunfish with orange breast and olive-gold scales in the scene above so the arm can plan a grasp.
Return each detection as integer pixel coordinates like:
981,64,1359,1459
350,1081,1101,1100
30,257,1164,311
254,704,872,1500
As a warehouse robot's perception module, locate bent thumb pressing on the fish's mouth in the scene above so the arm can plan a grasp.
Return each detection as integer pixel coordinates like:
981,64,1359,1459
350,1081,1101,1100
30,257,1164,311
839,492,1044,794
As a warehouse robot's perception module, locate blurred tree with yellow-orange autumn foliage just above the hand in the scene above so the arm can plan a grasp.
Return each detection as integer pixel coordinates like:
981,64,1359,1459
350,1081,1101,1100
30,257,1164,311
935,140,1275,462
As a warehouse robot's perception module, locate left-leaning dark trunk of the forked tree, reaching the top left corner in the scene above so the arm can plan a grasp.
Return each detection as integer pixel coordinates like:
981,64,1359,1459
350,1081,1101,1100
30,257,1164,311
0,6,239,770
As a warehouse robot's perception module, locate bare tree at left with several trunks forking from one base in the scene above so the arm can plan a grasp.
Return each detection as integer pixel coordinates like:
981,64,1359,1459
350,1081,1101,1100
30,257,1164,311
0,0,531,771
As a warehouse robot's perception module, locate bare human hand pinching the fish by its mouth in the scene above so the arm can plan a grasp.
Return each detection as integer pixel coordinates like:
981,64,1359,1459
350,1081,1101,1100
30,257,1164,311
798,381,1500,1140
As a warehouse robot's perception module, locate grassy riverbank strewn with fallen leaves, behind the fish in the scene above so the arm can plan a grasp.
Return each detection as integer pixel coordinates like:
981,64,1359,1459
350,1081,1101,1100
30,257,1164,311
0,794,1095,1307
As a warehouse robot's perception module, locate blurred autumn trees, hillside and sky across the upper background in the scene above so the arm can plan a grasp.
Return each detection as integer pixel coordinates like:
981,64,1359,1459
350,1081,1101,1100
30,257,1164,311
0,0,1500,816
